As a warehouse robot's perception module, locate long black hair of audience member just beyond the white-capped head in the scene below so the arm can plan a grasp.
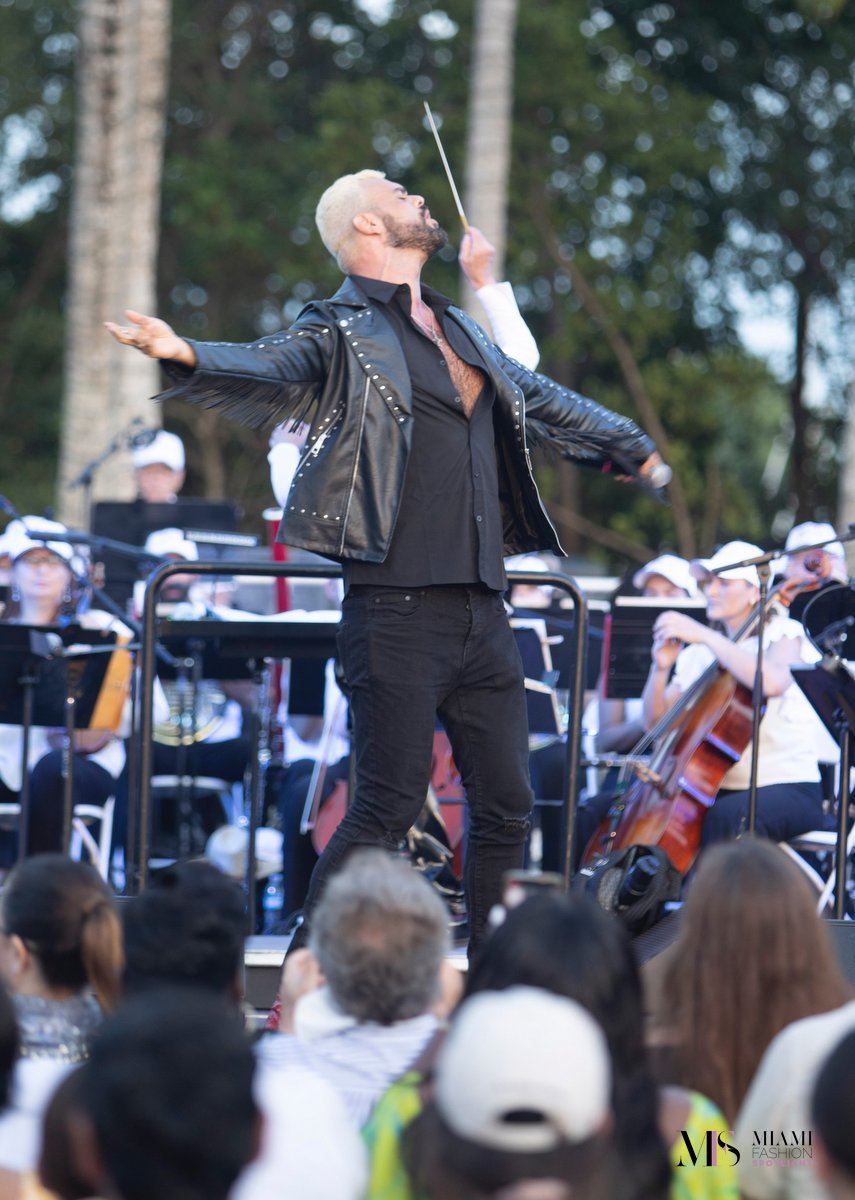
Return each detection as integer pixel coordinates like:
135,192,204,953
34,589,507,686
466,893,671,1200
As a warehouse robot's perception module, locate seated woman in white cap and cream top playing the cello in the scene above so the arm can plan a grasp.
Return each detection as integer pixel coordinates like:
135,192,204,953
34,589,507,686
644,541,824,845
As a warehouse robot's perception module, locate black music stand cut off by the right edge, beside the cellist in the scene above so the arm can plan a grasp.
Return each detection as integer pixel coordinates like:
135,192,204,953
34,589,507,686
790,658,855,920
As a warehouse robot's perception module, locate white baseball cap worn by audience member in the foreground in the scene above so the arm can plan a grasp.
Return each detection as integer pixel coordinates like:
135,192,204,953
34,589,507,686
434,988,611,1153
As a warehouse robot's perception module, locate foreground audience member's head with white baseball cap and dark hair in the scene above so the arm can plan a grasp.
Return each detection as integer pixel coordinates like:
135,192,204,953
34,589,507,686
406,988,611,1200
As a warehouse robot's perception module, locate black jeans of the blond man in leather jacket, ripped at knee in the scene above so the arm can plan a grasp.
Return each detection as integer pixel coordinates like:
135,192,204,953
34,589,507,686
297,586,532,952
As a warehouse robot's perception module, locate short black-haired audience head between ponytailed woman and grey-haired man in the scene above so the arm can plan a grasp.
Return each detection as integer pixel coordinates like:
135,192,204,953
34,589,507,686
122,862,246,1003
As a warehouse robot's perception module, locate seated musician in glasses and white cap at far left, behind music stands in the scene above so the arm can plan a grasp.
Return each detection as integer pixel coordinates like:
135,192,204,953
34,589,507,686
0,517,130,865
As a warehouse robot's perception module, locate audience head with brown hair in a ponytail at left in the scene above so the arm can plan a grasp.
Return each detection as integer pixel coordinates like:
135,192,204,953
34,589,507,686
0,854,122,1010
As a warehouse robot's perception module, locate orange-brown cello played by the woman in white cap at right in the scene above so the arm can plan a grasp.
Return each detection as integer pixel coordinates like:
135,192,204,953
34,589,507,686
581,571,818,874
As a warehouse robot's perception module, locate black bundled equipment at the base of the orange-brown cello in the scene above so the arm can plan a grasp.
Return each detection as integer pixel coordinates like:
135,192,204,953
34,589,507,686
573,846,683,934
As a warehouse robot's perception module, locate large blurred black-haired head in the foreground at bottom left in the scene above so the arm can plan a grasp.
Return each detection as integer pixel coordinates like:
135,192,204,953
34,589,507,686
77,989,259,1200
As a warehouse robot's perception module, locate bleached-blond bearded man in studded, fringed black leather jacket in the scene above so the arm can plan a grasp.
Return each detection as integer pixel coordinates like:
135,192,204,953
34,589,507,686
107,170,660,952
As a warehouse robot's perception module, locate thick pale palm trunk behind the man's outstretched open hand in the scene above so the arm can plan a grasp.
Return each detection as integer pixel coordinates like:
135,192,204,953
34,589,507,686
58,0,171,523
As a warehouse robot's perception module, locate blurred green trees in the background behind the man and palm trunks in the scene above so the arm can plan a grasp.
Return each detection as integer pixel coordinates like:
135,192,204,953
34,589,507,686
0,0,855,568
